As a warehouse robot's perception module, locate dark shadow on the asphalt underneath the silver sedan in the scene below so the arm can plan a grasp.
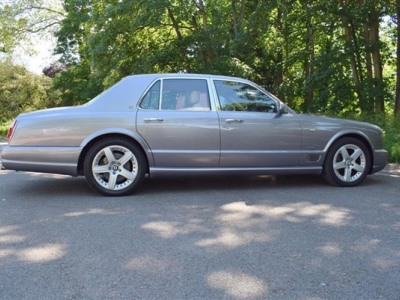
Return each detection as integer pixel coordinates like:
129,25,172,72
9,170,384,197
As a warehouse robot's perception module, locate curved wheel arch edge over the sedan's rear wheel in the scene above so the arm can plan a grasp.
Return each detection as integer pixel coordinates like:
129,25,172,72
78,133,152,175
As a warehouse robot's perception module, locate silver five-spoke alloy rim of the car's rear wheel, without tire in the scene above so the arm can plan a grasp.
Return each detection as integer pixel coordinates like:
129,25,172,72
92,145,138,190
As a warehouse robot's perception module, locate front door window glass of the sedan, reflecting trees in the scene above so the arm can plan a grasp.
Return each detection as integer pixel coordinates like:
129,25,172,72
214,80,277,113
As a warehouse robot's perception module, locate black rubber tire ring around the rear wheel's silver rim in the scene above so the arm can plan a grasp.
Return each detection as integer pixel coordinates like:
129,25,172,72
83,138,146,197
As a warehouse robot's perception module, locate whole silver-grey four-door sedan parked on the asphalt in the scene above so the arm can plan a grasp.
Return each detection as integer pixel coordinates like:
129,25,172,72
0,74,388,196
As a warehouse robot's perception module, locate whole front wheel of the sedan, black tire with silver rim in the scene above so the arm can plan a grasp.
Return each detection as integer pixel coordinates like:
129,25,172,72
322,137,371,187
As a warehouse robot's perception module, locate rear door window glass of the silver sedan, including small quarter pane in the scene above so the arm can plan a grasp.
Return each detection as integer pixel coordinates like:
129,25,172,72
140,79,211,111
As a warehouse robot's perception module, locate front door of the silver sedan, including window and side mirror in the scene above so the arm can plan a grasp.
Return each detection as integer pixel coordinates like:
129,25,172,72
214,80,301,168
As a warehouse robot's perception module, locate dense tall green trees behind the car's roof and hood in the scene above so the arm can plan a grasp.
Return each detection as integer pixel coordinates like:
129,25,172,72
47,0,395,114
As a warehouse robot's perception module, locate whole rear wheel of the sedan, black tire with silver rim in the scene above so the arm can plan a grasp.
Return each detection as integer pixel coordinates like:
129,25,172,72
83,138,146,196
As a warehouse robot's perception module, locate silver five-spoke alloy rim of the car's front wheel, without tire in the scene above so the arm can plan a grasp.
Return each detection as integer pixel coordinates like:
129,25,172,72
333,144,367,182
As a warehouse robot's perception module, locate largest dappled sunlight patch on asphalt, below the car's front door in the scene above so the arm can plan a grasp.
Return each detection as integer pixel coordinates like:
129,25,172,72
142,201,351,251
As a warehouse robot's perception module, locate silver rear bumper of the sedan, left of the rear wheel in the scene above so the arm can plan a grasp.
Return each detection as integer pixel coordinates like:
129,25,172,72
0,145,82,176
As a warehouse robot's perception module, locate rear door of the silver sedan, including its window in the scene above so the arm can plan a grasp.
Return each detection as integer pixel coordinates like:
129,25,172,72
136,78,220,168
